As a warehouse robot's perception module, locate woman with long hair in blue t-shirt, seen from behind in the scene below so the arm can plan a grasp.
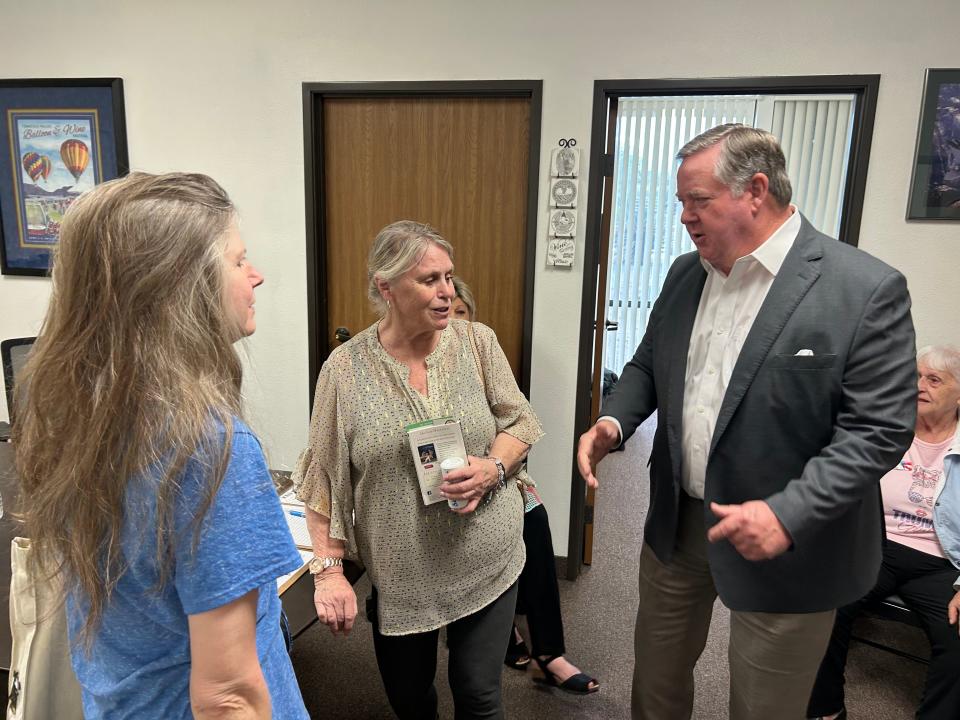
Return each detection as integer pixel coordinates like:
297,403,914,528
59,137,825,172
14,173,308,720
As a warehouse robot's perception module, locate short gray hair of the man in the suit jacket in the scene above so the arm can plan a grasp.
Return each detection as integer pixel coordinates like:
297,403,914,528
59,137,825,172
677,123,793,207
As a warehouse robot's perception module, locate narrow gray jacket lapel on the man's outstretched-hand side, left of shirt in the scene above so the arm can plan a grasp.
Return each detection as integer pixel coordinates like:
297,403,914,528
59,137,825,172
664,261,707,478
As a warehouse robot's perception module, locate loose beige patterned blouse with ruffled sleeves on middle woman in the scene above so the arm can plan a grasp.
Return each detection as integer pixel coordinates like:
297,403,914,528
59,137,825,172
294,320,543,635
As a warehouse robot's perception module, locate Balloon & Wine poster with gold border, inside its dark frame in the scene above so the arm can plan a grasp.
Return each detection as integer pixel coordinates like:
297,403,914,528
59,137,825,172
8,110,103,248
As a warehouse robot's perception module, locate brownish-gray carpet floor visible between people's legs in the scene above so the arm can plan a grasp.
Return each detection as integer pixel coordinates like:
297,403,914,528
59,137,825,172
293,414,926,720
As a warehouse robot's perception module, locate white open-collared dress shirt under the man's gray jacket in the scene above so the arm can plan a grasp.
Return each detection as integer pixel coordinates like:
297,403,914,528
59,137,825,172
680,208,800,498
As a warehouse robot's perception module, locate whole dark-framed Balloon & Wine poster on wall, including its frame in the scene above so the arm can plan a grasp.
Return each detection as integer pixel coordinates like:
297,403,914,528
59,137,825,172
0,78,129,276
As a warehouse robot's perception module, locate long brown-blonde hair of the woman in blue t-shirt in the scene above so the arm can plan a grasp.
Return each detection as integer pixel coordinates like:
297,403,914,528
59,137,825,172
14,173,241,649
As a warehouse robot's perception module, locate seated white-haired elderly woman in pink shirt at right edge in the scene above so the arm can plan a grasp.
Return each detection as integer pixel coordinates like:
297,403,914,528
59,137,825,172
807,345,960,720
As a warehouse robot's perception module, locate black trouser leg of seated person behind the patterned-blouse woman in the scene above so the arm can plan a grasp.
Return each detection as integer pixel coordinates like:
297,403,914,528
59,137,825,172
517,505,566,657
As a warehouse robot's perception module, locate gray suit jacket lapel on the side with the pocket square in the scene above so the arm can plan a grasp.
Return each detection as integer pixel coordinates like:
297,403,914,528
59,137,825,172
710,218,823,453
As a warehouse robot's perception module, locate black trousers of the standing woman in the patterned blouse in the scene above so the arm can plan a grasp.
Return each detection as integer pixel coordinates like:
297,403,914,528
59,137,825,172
370,583,517,720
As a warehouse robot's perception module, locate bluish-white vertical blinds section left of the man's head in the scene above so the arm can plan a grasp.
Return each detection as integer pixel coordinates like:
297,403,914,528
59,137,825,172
604,95,757,372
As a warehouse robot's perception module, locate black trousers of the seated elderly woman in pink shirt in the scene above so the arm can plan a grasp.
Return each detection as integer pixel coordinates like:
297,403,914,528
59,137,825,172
807,541,960,720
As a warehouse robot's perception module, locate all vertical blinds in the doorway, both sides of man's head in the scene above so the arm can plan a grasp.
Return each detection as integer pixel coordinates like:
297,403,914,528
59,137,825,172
604,95,853,372
